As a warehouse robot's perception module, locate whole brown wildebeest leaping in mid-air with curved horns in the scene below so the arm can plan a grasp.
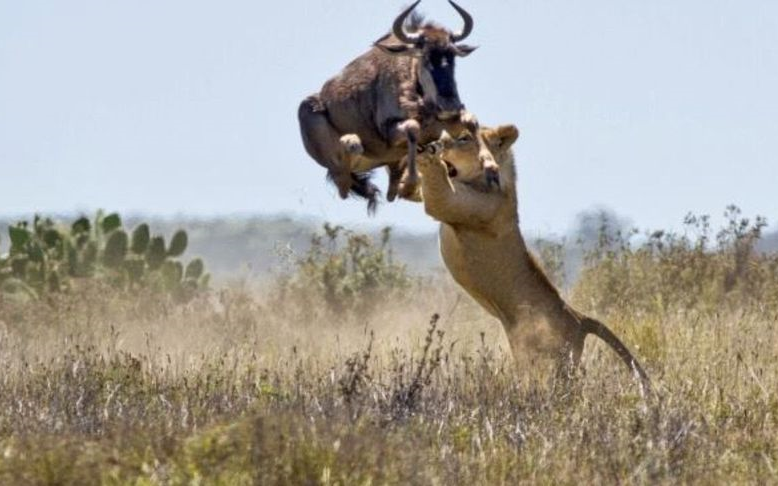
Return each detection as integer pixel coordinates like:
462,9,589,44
298,0,499,211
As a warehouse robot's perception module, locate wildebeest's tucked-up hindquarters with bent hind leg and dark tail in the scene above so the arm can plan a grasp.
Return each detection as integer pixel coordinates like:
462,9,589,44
297,95,380,211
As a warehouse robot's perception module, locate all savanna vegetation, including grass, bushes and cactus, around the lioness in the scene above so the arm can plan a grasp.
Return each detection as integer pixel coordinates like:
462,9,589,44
0,207,778,485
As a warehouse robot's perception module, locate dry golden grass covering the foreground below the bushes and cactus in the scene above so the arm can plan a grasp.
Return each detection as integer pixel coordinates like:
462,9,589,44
0,219,778,484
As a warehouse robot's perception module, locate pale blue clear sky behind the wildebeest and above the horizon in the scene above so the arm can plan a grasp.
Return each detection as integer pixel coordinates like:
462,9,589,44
0,0,778,232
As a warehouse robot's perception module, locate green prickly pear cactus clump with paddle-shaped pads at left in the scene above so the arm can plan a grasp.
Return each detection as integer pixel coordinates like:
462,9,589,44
0,212,209,300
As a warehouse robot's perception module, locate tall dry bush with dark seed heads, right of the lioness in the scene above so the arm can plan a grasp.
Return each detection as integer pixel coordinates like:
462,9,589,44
572,206,778,316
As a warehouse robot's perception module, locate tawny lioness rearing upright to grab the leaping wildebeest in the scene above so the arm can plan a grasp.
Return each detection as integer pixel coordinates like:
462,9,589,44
419,125,650,391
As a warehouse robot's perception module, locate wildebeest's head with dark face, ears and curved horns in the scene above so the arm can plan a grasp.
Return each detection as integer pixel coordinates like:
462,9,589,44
375,0,476,118
